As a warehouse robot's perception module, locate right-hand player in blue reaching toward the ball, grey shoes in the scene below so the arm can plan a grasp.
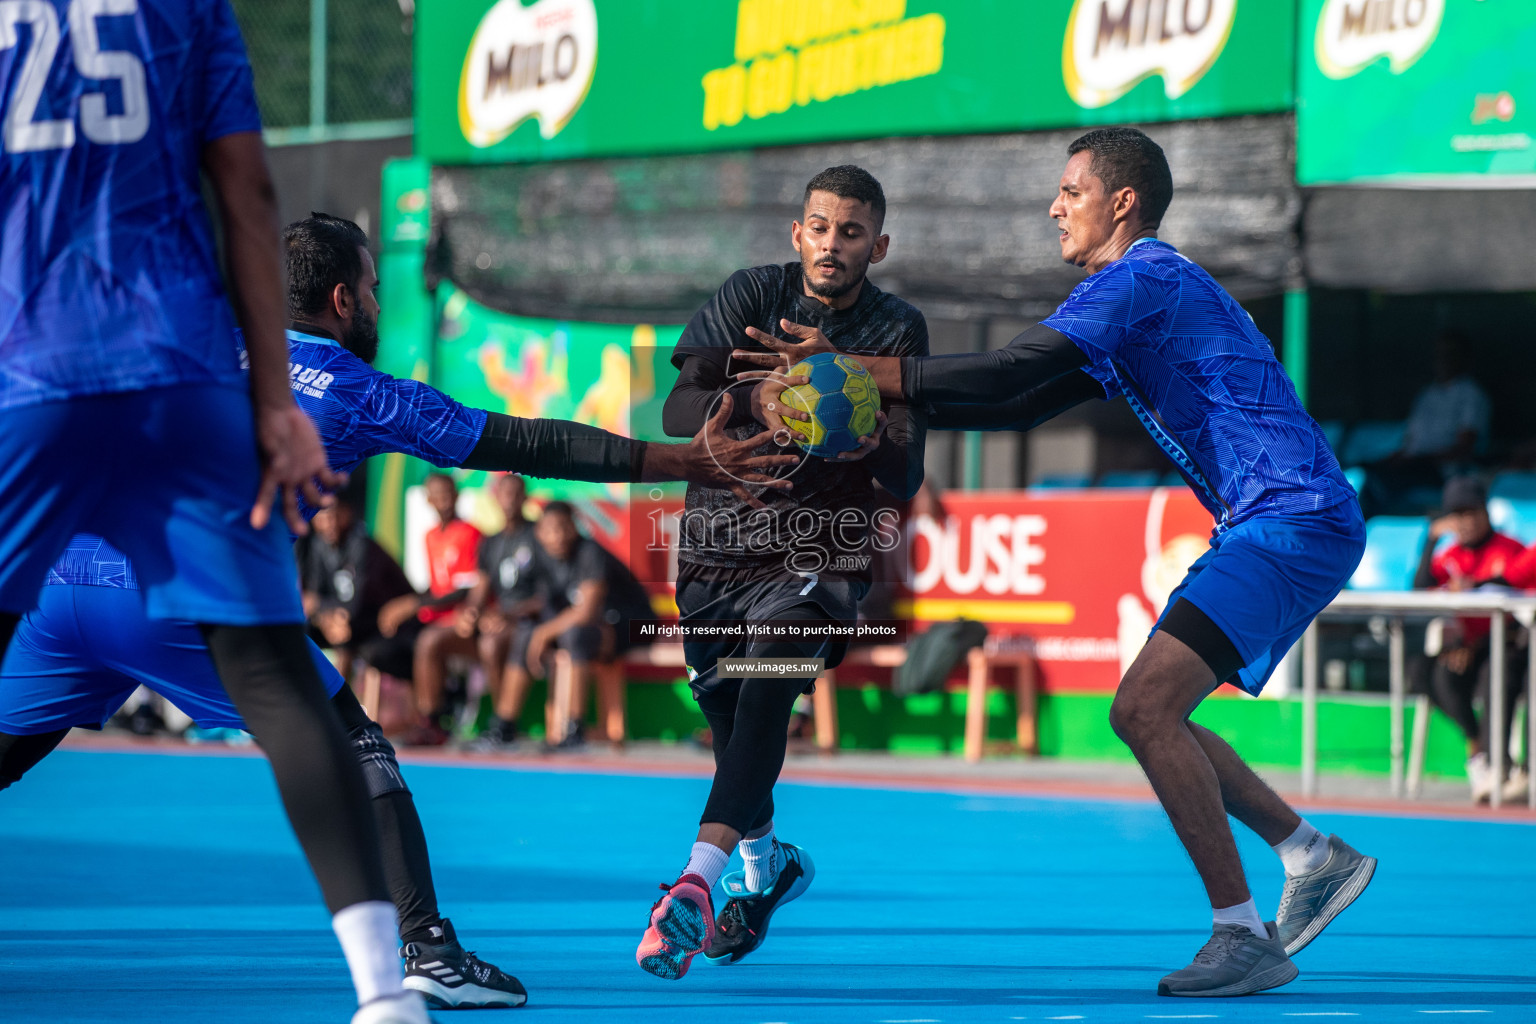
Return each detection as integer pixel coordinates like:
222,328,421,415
736,127,1376,996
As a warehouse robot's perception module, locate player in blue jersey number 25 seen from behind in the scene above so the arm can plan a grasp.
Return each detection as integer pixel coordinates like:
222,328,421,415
0,0,427,1024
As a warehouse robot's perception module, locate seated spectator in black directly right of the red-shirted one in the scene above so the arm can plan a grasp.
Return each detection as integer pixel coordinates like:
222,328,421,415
459,473,544,751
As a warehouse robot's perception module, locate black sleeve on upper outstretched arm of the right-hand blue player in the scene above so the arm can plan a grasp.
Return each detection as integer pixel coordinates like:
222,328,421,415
902,324,1103,411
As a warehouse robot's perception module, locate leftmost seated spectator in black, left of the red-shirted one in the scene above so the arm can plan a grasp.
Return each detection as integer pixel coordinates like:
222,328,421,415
300,497,416,679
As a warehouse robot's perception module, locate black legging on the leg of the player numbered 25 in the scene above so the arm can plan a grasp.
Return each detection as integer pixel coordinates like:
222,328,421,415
201,625,390,913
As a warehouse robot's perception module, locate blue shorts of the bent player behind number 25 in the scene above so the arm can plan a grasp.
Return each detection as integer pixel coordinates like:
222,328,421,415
0,585,344,735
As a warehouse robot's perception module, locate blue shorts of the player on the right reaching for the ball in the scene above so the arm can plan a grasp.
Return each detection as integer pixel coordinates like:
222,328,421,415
1154,499,1366,697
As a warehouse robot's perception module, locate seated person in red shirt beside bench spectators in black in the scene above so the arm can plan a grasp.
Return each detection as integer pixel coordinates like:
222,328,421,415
358,473,481,743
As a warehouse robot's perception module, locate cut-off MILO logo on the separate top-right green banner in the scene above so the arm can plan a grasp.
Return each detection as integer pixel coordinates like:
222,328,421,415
1316,0,1445,78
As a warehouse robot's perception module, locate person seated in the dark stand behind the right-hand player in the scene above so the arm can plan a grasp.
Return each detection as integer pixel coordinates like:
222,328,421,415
1366,330,1490,516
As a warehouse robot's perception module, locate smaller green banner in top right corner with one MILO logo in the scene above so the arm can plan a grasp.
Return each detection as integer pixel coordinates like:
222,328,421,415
1296,0,1536,186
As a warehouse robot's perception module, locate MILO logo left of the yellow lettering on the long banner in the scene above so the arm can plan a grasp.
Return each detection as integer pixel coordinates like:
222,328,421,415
459,0,598,147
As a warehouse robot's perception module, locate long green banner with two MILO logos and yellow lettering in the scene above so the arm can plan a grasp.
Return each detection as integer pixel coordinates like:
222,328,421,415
415,0,1296,164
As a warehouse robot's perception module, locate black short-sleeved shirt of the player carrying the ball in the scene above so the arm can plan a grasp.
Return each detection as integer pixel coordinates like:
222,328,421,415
664,263,928,580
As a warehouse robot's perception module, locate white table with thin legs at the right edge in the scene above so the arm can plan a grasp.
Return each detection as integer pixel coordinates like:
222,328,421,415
1301,590,1536,808
